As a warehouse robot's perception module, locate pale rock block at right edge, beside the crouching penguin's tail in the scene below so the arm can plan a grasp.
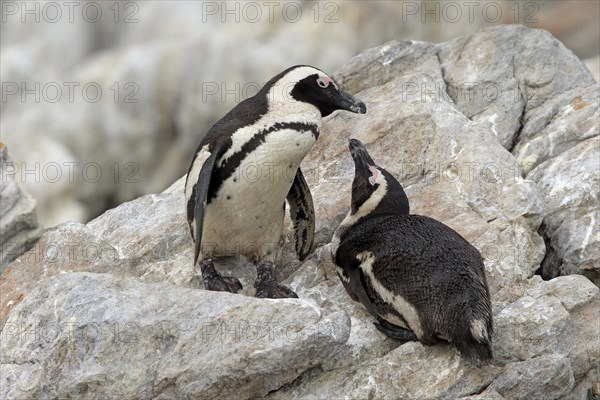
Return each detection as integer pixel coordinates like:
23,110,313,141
494,275,600,379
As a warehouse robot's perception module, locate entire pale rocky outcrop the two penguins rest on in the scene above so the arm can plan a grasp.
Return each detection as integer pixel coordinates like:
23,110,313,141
0,26,600,400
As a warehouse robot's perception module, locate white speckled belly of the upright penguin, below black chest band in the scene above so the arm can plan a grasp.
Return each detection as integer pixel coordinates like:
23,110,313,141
202,129,315,261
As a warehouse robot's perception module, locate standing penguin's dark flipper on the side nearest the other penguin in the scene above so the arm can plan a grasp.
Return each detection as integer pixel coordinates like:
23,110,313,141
284,168,315,261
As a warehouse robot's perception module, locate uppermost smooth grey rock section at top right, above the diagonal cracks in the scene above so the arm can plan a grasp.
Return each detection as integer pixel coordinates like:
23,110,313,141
439,25,595,149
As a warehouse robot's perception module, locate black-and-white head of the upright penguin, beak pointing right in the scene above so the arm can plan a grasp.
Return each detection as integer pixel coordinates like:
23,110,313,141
263,65,367,117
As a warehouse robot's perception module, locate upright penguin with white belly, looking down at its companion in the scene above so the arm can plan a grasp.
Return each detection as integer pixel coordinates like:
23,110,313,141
185,65,366,298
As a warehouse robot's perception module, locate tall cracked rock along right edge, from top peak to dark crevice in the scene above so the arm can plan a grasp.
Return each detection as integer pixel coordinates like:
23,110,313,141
438,26,600,282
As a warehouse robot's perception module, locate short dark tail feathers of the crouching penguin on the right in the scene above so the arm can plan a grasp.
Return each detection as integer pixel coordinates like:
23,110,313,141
453,319,494,367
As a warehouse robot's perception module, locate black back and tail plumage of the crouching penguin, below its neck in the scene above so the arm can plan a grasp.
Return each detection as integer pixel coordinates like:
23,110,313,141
336,214,493,362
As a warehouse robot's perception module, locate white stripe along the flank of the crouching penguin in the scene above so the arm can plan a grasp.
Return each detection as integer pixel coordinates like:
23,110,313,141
356,251,423,339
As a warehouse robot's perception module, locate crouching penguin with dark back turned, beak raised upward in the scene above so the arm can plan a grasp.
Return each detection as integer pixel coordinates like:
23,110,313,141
332,139,493,365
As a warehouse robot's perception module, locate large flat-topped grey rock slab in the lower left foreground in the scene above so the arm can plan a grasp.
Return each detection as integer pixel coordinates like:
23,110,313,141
0,273,350,399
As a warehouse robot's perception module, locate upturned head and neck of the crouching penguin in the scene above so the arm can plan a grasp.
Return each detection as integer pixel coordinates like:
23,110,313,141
348,139,410,215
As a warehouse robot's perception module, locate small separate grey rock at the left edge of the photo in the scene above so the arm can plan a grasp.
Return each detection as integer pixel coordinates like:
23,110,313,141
0,142,43,273
